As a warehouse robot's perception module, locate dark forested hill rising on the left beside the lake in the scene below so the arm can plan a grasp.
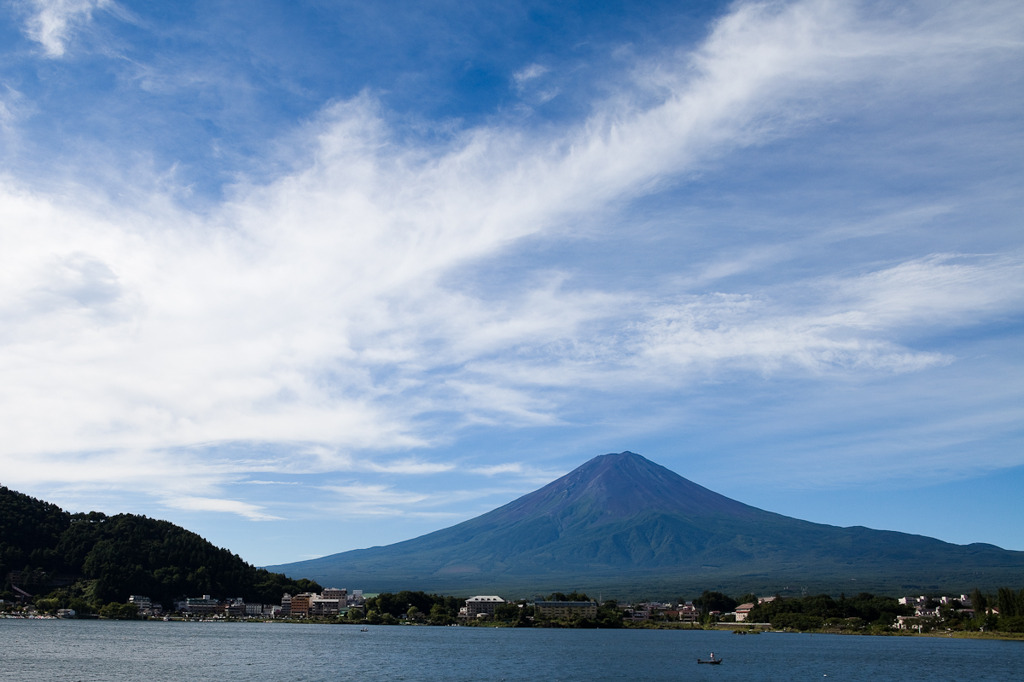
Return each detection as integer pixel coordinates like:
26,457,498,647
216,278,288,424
0,486,319,605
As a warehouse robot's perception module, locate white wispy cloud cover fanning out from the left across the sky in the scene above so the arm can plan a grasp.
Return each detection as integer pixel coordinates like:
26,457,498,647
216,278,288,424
0,2,1022,509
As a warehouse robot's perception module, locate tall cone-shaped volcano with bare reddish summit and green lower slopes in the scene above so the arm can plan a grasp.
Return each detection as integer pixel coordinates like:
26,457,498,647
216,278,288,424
268,453,1024,597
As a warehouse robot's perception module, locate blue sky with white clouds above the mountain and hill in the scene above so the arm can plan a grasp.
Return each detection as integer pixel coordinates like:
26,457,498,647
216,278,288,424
0,0,1024,561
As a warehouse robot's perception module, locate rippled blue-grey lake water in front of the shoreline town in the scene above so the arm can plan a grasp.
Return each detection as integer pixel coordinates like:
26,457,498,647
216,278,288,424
0,620,1024,682
